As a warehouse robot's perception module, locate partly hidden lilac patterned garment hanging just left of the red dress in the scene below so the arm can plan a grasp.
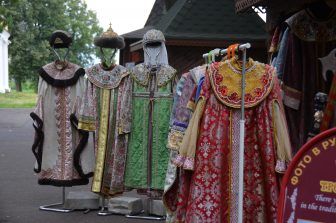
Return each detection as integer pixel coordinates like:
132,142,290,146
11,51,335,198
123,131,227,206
162,66,205,222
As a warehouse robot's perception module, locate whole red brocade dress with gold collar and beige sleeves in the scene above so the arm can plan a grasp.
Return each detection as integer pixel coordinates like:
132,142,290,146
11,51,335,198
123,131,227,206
175,59,291,223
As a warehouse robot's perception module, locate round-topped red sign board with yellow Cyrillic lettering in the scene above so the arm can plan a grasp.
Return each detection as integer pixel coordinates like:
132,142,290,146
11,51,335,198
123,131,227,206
277,128,336,223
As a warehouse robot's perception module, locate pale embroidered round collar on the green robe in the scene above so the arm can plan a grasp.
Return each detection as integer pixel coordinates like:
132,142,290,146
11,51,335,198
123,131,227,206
132,63,176,87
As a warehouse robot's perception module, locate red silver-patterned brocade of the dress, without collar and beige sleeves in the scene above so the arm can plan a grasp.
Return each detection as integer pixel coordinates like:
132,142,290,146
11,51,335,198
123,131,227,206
173,62,288,223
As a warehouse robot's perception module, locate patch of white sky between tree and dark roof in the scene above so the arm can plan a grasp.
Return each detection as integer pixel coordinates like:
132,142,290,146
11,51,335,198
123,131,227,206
85,0,155,35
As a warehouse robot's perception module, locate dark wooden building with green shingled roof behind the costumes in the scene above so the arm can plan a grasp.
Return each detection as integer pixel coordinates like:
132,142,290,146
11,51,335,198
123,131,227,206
120,0,267,74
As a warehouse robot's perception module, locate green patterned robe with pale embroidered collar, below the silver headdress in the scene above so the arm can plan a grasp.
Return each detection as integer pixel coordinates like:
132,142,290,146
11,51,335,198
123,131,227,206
125,64,176,190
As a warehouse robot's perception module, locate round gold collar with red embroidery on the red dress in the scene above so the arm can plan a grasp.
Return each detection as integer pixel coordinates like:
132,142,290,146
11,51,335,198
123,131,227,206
209,59,274,108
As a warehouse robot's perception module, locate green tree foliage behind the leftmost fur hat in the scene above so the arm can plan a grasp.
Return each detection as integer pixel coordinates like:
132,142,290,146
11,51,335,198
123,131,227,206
0,0,102,90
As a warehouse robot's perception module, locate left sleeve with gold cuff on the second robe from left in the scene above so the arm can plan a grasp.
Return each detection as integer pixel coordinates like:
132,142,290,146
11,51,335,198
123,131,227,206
78,78,96,131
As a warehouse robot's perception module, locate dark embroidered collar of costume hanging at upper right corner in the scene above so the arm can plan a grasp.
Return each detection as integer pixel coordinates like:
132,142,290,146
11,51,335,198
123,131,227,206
286,10,336,41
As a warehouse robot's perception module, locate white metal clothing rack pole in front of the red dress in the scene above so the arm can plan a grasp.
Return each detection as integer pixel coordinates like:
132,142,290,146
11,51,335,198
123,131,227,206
203,43,251,223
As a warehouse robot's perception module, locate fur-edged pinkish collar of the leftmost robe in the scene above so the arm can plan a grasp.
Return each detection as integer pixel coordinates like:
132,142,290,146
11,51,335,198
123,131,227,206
39,62,85,87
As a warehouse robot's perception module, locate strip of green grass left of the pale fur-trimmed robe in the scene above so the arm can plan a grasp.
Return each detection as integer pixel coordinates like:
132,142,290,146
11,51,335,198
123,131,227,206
0,90,36,108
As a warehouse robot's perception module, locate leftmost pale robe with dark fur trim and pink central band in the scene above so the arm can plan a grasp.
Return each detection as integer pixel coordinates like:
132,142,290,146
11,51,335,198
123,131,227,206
30,62,93,186
